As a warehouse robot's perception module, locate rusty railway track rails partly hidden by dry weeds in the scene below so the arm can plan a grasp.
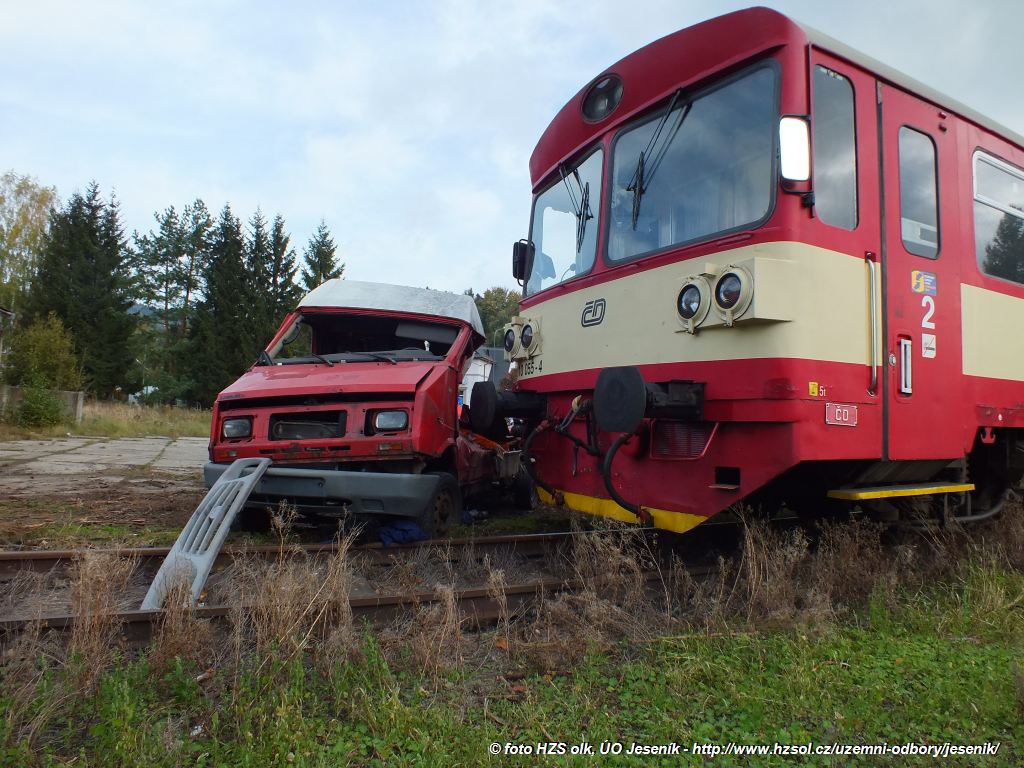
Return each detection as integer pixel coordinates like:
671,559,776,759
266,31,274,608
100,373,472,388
0,531,702,646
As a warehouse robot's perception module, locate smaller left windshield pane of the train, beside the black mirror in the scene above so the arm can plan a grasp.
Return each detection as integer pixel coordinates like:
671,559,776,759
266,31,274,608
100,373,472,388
526,150,604,296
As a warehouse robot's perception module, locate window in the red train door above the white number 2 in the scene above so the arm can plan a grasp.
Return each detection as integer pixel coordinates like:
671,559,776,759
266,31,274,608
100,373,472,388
899,126,939,259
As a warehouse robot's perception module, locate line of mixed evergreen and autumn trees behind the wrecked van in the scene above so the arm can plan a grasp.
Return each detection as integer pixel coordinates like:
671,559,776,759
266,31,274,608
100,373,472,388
0,172,519,407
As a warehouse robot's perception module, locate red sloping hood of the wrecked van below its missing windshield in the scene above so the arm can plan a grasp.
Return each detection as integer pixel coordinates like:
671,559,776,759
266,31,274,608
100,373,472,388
217,360,446,402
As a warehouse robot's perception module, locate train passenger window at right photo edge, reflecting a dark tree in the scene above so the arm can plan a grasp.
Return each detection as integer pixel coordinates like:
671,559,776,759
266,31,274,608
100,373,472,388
974,152,1024,283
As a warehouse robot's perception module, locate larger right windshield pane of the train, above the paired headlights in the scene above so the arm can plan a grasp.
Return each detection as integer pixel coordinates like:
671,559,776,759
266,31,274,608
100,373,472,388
608,67,778,261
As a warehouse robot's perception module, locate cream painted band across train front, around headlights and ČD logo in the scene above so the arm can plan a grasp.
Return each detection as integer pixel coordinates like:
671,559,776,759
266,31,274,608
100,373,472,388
521,242,882,378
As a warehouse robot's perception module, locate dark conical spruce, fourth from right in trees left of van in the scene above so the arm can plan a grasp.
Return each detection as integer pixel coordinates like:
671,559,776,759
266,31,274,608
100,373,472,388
187,205,254,406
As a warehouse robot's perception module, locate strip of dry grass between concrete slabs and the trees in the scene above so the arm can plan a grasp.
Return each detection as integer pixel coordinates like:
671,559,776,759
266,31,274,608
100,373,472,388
0,400,210,440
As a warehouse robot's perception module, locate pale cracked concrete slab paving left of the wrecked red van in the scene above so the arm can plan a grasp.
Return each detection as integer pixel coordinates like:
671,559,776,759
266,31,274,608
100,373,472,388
0,437,207,497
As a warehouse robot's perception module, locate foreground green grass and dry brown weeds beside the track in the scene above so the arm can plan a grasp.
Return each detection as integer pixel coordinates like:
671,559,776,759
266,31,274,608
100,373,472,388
6,508,1024,766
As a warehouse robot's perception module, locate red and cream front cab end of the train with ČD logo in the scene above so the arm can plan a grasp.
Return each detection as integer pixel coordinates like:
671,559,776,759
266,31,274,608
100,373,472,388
491,8,882,532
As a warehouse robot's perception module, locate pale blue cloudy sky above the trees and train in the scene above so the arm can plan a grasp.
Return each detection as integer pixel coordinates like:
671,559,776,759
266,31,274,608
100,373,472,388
0,0,1024,293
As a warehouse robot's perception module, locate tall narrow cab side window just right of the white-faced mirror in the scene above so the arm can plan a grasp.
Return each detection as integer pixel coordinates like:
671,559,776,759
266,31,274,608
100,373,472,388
812,65,857,229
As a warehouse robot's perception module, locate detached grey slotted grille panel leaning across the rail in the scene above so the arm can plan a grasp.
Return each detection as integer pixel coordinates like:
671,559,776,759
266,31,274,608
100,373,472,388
142,459,270,610
